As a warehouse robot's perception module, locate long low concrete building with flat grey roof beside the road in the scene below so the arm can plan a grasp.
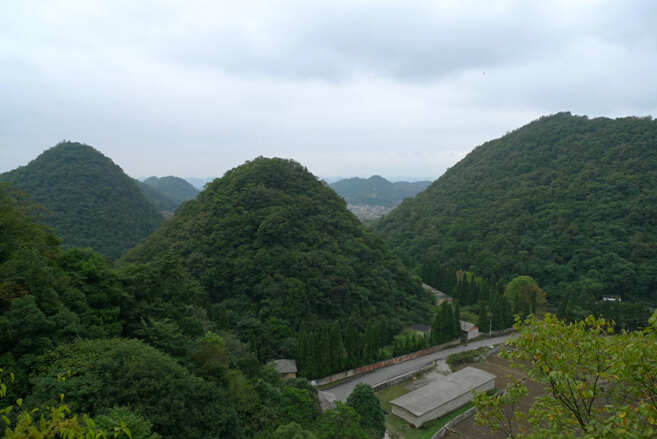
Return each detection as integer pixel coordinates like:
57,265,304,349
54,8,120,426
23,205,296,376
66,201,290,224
390,367,495,428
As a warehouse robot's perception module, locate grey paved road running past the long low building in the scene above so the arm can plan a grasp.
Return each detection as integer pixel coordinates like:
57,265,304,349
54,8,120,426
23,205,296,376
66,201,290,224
324,334,510,402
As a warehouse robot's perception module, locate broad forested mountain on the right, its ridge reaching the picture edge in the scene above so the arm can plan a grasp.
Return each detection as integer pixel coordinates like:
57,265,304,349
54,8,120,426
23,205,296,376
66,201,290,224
372,113,657,304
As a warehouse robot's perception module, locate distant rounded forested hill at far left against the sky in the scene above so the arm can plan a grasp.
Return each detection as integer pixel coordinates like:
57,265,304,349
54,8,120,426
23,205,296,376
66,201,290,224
0,142,164,259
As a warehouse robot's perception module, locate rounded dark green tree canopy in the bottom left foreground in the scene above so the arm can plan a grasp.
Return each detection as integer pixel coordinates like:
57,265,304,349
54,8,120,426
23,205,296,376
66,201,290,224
29,339,242,438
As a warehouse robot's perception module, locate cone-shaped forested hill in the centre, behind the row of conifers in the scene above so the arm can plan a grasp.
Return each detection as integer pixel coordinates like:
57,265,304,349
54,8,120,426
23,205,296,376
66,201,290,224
121,157,431,337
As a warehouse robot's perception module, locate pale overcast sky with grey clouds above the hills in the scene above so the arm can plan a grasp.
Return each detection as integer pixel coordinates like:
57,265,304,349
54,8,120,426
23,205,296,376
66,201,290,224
0,0,657,180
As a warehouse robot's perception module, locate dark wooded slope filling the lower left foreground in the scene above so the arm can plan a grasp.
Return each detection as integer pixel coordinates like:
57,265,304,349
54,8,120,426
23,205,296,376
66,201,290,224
0,183,383,439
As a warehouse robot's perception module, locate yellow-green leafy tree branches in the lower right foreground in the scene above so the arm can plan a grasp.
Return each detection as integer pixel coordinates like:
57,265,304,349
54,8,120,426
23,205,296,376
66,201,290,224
474,313,657,439
